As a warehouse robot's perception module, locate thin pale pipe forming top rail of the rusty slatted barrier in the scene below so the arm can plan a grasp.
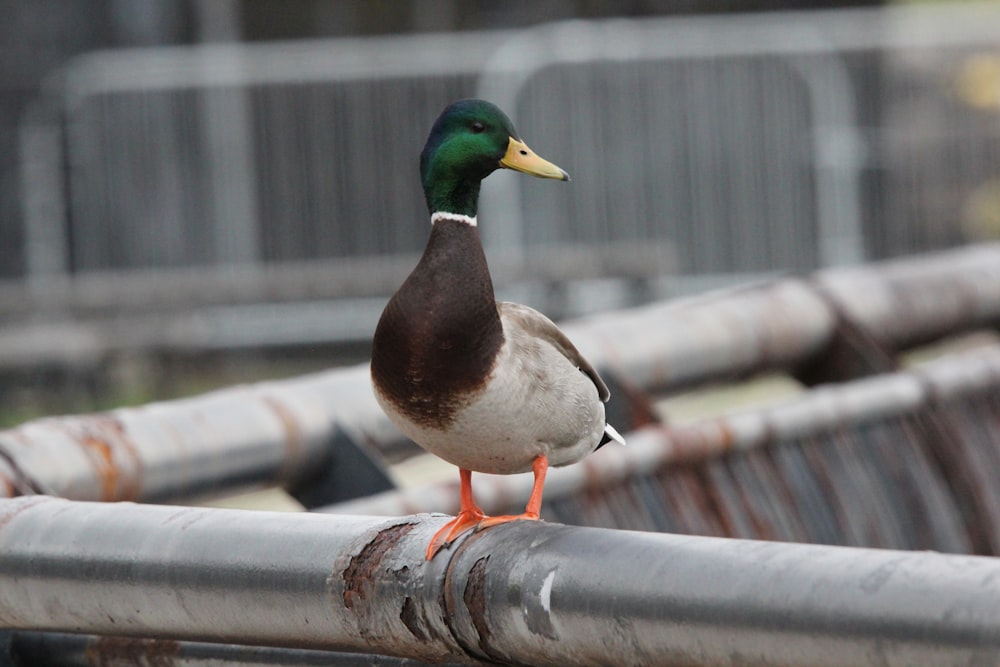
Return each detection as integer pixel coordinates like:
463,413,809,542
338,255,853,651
320,344,1000,516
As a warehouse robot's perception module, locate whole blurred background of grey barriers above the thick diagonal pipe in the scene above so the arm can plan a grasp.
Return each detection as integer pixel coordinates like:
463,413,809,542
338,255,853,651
0,0,1000,424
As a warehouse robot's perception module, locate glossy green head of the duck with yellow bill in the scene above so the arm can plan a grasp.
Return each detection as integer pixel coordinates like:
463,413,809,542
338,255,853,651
420,100,569,217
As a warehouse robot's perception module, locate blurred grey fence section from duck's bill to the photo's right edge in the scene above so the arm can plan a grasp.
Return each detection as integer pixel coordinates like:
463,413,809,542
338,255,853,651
479,3,1000,272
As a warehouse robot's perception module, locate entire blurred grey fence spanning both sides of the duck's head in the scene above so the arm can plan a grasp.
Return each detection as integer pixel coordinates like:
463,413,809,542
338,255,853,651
11,6,1000,294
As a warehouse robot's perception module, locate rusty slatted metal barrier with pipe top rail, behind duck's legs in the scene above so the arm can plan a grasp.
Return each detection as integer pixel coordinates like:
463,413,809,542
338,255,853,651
321,342,1000,555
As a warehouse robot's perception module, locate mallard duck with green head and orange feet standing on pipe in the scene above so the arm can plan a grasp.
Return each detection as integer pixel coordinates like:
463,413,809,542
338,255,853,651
371,99,625,560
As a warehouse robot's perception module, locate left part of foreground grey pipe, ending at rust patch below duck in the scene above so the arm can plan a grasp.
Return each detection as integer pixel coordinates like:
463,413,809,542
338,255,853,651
0,496,465,660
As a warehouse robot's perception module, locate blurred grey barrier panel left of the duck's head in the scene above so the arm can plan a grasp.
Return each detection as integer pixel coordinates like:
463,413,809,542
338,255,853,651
23,32,507,274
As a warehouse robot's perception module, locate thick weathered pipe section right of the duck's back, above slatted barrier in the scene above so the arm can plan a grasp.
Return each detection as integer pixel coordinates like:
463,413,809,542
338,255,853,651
563,244,1000,391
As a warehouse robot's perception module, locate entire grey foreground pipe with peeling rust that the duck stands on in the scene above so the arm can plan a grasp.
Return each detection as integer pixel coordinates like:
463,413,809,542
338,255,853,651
0,497,1000,667
